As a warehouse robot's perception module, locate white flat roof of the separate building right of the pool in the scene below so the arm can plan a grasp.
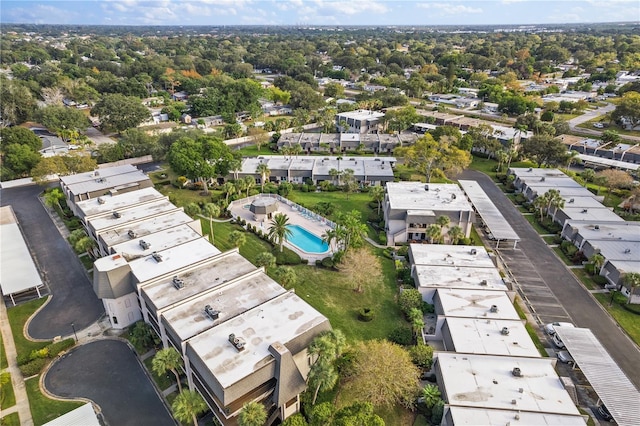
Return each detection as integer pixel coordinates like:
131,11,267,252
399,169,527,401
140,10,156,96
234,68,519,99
387,182,473,211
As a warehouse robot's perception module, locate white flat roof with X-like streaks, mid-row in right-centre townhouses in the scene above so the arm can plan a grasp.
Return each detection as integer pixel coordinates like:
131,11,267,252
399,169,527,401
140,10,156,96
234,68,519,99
434,288,520,320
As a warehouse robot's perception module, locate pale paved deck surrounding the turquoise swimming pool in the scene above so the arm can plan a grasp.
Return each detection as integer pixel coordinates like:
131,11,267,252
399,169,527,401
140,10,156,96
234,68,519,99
229,195,334,265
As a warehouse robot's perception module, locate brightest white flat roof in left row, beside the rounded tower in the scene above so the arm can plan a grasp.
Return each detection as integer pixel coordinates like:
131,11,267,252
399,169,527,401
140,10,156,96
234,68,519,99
129,238,220,283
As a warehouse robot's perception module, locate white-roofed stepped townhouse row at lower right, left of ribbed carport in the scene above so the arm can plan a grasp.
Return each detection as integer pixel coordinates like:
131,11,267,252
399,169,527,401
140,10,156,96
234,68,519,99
409,244,585,425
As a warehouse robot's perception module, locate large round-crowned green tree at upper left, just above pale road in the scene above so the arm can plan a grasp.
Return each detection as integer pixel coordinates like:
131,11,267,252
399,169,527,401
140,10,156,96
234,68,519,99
91,93,151,133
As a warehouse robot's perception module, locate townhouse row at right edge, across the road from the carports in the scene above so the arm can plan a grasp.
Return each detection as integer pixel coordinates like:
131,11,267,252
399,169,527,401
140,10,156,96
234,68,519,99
508,167,640,303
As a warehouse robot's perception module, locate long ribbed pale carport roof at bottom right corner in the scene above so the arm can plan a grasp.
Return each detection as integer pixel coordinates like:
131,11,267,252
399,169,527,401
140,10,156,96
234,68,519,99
556,327,640,426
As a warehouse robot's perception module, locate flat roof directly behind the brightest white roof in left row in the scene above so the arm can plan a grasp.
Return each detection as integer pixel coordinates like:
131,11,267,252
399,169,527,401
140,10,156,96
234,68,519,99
111,224,202,259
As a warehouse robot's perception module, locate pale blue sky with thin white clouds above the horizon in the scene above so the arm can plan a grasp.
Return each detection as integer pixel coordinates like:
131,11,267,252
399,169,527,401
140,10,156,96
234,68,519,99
0,0,640,26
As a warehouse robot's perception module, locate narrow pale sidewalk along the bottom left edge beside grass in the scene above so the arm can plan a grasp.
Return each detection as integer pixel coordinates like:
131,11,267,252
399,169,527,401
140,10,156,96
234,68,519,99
0,301,33,426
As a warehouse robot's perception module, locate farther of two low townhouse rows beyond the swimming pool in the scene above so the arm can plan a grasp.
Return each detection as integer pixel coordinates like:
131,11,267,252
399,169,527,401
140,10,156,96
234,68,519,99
277,133,418,154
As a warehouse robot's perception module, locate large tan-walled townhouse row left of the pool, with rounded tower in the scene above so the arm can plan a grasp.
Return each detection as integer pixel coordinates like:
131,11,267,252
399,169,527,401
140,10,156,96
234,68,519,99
60,168,331,425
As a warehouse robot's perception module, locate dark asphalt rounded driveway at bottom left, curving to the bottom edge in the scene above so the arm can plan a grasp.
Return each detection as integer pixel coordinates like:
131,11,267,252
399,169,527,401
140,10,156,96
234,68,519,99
44,340,176,426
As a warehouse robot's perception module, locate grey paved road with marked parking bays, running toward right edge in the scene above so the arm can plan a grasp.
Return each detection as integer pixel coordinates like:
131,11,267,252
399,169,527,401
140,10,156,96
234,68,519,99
459,170,640,389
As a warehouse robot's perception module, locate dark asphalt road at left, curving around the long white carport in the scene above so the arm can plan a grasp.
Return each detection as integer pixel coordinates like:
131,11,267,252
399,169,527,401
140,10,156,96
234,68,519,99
1,185,104,339
